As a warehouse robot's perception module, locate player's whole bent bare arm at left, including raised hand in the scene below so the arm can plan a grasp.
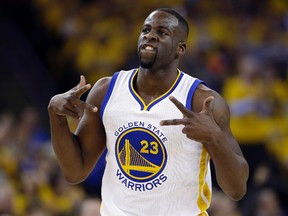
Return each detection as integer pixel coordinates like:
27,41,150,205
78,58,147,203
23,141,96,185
48,76,110,183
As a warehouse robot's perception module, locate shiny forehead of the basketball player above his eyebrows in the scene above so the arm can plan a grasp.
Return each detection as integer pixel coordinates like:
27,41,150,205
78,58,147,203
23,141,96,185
144,11,178,29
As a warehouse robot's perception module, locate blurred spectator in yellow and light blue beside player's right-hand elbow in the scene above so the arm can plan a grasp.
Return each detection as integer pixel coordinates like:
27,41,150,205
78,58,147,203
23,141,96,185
222,54,288,186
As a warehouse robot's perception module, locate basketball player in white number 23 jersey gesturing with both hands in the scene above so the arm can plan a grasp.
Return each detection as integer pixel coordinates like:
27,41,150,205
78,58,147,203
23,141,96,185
48,9,248,216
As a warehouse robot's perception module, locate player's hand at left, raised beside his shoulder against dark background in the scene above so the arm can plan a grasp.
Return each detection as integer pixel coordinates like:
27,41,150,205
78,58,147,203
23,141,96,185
48,75,98,119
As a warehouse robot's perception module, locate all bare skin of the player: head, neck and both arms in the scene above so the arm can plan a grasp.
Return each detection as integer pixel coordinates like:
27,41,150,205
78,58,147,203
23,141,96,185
48,11,248,200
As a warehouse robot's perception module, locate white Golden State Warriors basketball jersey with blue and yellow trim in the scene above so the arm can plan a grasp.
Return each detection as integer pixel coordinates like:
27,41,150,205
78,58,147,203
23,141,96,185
100,69,211,216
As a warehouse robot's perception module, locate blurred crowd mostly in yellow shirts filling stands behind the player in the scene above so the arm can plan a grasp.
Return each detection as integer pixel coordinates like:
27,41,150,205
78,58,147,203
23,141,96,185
0,0,288,216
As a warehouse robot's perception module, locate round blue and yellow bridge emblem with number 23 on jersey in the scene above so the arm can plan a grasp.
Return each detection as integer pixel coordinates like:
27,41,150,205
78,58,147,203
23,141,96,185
115,128,167,182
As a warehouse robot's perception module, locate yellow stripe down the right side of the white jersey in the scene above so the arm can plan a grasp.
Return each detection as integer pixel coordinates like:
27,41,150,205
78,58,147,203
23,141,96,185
197,148,211,213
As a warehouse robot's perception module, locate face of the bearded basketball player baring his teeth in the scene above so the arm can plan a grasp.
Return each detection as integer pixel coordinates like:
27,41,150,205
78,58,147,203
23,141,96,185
138,11,179,68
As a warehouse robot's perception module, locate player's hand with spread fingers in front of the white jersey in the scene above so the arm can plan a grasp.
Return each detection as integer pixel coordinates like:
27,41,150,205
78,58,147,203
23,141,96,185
160,96,220,143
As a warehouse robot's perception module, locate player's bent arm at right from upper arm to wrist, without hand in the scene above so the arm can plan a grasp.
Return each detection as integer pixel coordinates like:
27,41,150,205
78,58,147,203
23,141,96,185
202,92,249,200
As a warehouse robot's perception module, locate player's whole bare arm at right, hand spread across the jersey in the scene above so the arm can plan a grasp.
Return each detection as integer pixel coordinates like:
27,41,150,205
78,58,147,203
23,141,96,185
161,84,249,200
